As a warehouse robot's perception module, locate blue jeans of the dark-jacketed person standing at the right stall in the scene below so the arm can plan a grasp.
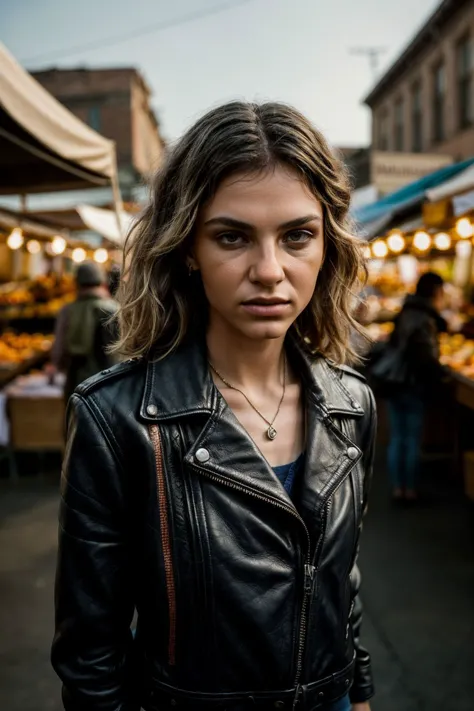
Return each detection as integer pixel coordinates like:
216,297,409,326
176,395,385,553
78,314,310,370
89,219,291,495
388,392,424,490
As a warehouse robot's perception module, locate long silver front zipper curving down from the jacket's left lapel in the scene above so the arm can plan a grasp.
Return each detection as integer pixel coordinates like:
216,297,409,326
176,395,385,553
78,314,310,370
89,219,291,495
191,467,316,688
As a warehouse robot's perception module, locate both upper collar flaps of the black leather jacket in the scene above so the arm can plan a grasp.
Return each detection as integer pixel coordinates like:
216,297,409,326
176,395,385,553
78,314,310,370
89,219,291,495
140,339,364,422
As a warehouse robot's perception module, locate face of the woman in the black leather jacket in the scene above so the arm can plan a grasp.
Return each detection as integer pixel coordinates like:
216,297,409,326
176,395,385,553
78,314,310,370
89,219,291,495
190,166,324,340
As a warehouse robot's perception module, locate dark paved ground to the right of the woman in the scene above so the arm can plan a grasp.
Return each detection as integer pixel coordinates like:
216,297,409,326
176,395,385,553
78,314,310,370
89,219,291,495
361,454,474,711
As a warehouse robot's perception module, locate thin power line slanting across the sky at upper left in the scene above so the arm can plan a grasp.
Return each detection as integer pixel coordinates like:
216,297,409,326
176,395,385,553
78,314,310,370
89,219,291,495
22,0,254,64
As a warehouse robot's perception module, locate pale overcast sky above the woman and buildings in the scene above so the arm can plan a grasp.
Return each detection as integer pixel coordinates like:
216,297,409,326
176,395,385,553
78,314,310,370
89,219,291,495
0,0,439,145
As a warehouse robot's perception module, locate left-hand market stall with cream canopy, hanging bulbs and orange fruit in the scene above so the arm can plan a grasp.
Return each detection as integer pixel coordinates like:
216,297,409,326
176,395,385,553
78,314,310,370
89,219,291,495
0,44,126,470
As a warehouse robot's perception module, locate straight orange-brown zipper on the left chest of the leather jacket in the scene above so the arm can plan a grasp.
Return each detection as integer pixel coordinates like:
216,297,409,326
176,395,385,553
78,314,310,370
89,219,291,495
150,425,176,666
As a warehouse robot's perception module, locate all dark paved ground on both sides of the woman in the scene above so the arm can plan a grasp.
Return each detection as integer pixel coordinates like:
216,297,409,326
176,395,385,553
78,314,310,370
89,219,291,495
0,454,474,711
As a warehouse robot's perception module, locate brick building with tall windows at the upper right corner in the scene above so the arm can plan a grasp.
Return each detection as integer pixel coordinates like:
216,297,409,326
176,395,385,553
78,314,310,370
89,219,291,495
365,0,474,161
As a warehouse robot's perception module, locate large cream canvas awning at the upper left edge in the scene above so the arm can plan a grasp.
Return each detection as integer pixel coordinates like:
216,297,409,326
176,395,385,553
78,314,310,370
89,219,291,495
0,43,117,194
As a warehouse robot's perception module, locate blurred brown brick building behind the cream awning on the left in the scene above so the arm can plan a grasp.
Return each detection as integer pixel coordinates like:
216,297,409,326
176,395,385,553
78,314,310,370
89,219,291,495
31,68,164,197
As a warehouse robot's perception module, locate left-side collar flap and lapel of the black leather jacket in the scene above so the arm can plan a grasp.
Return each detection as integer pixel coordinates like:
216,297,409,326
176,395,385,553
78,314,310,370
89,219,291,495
140,342,294,509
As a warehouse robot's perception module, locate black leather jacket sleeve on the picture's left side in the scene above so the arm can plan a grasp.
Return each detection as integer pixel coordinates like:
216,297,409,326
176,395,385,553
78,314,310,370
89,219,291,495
51,394,140,711
